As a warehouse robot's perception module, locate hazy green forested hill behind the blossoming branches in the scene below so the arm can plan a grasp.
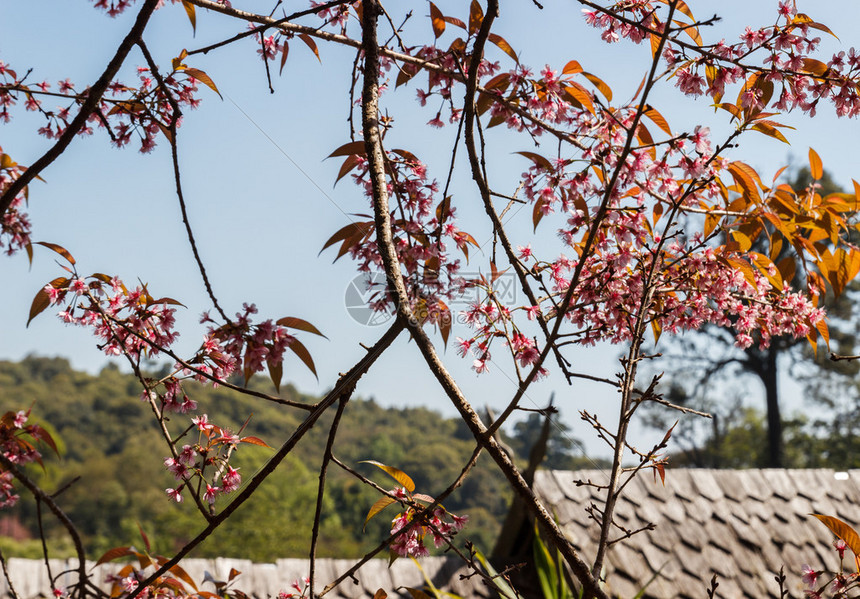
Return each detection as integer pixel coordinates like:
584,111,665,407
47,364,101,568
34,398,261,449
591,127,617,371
0,357,533,561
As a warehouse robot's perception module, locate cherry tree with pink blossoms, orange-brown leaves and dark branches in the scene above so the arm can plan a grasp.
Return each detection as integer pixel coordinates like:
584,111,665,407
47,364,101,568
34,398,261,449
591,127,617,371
0,0,860,599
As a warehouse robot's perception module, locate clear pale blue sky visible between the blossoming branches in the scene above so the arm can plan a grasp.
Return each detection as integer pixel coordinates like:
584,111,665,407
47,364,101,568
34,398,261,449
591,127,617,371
0,0,860,460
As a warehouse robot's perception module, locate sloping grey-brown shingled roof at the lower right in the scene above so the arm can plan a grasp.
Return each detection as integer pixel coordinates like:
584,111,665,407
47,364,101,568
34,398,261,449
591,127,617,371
534,469,860,599
